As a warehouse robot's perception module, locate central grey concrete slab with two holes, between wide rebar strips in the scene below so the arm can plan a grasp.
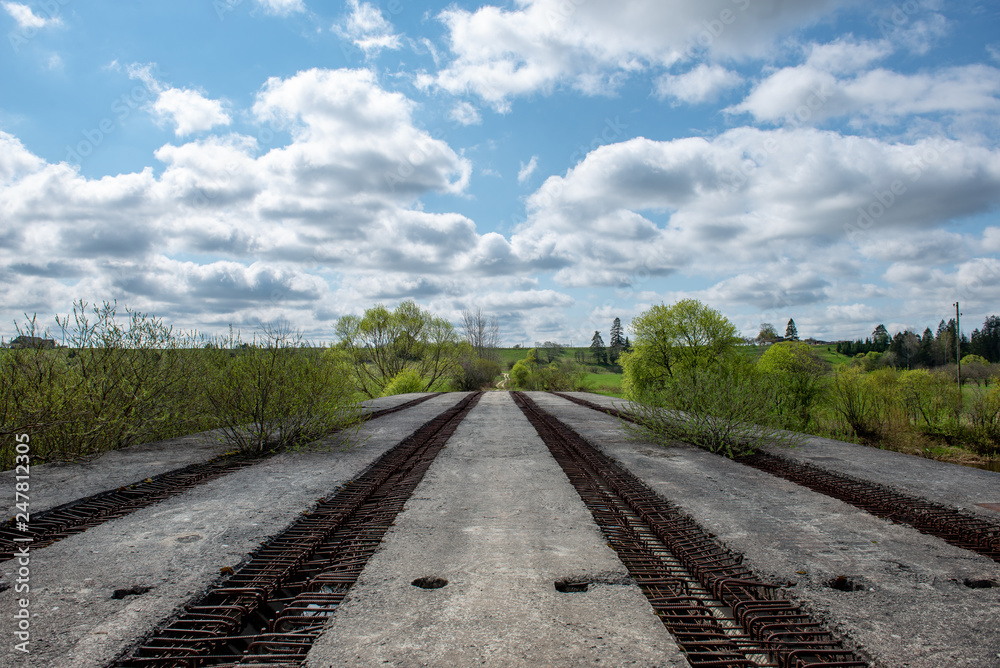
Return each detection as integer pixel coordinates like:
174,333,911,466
306,393,687,668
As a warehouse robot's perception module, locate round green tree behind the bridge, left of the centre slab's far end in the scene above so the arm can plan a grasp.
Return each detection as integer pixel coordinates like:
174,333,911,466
336,301,461,398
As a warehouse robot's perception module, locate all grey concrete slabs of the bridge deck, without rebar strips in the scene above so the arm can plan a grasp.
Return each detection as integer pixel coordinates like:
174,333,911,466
0,392,1000,668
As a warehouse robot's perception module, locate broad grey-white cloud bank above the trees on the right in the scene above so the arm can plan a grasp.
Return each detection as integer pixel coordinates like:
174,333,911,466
511,128,1000,288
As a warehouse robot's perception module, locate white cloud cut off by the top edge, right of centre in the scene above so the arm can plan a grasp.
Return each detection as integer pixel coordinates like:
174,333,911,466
417,0,847,111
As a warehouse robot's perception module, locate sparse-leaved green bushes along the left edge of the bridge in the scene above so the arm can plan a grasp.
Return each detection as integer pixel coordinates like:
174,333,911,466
0,301,359,469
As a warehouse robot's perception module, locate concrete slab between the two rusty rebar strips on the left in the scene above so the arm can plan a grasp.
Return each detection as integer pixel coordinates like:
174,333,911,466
0,394,465,668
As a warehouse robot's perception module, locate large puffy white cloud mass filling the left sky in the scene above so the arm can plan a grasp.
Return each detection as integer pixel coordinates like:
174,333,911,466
0,69,494,334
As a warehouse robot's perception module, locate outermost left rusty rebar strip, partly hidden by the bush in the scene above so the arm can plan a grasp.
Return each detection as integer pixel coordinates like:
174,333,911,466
0,392,441,561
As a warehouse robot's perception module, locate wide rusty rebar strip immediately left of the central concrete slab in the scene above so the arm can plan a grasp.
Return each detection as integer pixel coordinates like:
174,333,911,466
114,393,482,668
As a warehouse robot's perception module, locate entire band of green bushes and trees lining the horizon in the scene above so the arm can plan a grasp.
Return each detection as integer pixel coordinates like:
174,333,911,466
0,300,1000,469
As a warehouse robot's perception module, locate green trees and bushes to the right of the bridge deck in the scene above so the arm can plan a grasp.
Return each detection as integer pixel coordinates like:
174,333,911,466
621,300,1000,463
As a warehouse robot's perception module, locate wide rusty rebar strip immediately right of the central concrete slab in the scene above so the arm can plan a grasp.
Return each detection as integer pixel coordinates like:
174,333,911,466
513,392,868,668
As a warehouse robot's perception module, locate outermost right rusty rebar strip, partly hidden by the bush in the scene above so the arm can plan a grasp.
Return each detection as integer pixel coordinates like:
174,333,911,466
553,392,1000,561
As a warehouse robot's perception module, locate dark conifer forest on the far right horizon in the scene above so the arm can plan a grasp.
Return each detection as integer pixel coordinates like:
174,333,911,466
837,315,1000,369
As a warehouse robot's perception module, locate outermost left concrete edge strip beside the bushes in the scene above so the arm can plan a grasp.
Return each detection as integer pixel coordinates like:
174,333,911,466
0,393,422,519
